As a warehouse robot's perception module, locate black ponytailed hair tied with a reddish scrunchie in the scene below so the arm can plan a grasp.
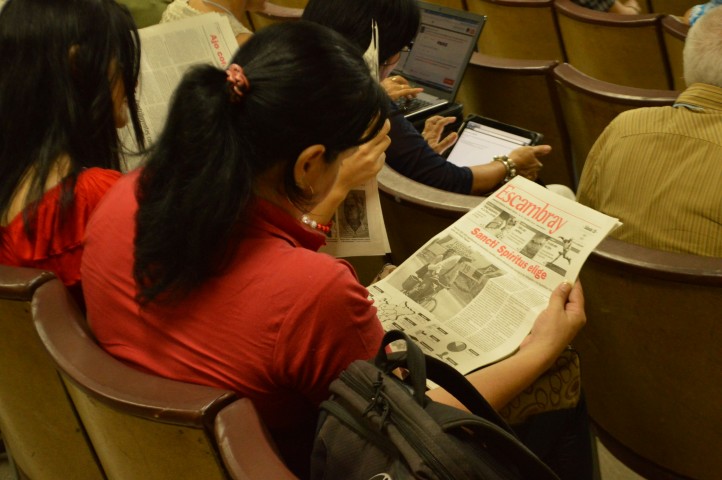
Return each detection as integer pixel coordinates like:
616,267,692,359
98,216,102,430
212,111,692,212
133,21,388,305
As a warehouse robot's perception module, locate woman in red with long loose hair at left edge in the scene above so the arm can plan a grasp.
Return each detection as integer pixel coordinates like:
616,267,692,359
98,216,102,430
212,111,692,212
0,0,142,304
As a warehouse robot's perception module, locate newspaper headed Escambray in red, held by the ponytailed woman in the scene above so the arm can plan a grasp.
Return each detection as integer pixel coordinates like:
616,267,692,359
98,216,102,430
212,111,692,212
369,177,620,374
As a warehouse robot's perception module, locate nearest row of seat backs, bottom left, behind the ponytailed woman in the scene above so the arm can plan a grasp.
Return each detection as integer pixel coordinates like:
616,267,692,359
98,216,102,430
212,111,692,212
0,265,295,480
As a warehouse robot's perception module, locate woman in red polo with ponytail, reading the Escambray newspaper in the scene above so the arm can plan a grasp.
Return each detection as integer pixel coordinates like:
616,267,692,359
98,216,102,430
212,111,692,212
81,21,584,476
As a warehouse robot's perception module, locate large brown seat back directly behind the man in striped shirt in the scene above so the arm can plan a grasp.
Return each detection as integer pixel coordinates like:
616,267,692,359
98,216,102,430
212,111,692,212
575,238,722,480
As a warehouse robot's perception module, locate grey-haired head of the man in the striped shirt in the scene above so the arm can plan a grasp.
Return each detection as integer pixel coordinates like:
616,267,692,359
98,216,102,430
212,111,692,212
683,7,722,88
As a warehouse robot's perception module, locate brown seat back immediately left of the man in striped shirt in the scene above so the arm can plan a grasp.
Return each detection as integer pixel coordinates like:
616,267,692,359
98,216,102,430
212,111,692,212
554,64,679,188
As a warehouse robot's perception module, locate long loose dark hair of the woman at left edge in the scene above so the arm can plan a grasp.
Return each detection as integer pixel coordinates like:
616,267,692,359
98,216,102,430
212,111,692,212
0,0,143,229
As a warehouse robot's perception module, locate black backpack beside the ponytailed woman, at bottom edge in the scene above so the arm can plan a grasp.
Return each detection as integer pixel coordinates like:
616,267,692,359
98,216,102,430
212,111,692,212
311,330,558,480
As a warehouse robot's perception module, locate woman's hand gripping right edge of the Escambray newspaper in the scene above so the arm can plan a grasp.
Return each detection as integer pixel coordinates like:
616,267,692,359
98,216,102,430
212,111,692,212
519,281,587,360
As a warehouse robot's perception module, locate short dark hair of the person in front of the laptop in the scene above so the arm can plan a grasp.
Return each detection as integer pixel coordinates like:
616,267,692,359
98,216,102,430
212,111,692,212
303,0,421,64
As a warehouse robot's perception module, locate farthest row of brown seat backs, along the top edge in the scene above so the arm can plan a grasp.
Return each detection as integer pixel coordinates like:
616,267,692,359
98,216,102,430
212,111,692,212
247,0,697,89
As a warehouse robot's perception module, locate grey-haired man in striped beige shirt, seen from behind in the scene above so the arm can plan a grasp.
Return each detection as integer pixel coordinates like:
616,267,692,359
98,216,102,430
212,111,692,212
577,9,722,257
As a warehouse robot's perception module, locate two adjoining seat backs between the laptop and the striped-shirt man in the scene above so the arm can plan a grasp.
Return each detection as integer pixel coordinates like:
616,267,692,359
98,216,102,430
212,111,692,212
457,53,679,190
